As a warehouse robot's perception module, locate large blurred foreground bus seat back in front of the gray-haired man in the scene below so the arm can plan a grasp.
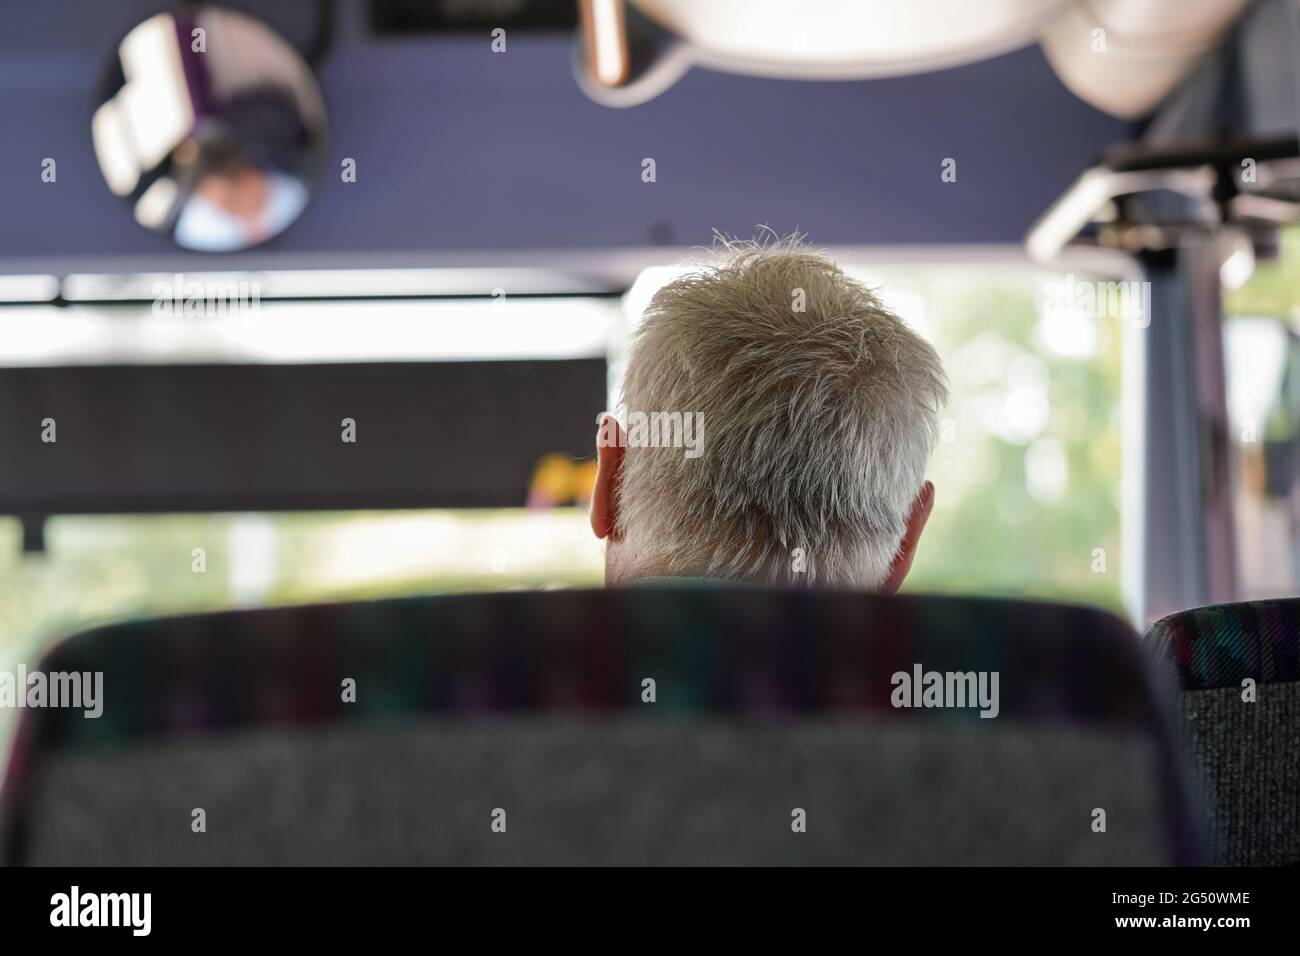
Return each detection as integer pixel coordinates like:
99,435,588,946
0,585,1199,865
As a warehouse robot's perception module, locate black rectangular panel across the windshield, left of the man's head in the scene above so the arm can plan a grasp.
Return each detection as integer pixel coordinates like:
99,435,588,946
0,359,606,515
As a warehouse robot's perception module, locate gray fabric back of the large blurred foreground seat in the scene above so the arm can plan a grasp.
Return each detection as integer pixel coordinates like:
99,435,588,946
29,718,1167,866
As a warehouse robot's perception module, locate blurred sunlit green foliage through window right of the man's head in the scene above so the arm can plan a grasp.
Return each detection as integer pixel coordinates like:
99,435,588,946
905,271,1122,611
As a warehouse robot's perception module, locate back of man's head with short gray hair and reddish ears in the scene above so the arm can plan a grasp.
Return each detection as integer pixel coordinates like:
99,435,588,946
592,239,948,591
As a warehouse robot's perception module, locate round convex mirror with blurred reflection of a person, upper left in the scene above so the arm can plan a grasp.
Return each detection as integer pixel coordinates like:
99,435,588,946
91,7,326,252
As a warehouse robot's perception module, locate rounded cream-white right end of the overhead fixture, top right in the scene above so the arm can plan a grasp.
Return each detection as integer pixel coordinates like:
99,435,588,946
1041,0,1253,120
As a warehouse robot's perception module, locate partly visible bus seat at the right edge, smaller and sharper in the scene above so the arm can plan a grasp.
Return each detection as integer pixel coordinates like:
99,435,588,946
1143,598,1300,866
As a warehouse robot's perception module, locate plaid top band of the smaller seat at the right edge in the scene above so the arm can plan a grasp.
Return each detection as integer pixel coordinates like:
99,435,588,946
1143,598,1300,691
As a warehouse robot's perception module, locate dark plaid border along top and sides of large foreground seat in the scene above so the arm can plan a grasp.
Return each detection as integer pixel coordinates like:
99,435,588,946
0,587,1195,862
